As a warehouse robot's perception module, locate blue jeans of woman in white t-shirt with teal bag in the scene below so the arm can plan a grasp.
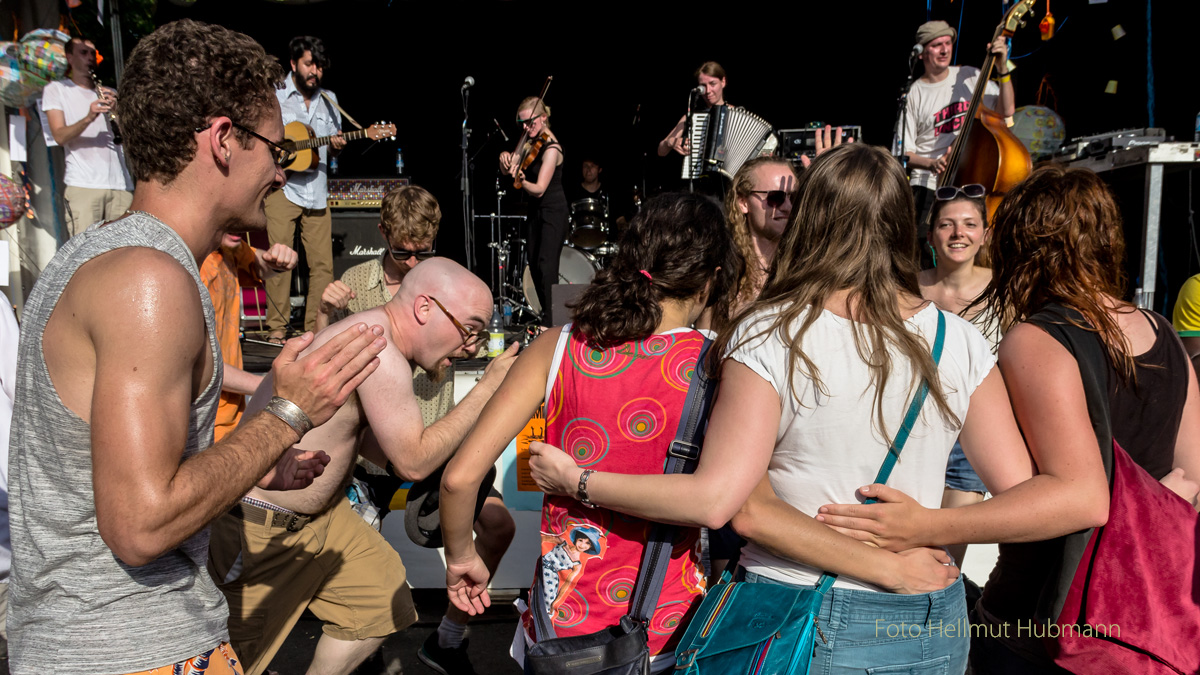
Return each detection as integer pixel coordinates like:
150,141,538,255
744,572,971,675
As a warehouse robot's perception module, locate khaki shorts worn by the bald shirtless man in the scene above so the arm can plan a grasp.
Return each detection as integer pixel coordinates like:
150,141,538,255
209,497,416,675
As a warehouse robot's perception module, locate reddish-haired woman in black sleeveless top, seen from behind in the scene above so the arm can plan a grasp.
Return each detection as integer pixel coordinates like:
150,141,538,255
821,167,1200,674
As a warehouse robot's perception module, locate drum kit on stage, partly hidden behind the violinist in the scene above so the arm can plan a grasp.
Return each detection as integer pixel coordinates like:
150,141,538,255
476,192,617,325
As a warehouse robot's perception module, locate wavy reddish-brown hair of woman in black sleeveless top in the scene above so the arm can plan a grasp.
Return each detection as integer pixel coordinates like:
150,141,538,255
974,166,1134,382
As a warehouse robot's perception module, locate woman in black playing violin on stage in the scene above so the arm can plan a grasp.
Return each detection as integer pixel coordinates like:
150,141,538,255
500,96,570,327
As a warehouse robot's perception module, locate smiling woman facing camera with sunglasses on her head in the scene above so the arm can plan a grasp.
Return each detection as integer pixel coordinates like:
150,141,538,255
917,184,1000,567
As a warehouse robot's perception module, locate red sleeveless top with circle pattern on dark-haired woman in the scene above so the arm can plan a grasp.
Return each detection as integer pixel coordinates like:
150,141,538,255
522,327,704,655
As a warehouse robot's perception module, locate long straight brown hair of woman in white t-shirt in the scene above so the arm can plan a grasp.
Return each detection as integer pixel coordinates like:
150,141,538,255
713,143,960,436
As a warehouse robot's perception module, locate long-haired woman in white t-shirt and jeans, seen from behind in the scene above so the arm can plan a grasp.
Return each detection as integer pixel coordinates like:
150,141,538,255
532,144,1031,673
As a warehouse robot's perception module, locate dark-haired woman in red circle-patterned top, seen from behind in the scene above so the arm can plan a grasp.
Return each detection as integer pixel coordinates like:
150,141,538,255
440,193,738,671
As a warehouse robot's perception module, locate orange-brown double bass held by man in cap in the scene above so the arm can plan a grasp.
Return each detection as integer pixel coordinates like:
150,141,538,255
937,0,1036,220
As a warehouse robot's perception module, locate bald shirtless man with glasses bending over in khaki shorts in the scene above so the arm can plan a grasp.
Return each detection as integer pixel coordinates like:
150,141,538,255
209,258,516,675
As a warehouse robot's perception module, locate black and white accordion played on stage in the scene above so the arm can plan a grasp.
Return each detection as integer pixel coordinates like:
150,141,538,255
683,106,779,180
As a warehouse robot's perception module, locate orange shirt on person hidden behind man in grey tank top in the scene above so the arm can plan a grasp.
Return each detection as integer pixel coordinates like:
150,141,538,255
200,240,260,442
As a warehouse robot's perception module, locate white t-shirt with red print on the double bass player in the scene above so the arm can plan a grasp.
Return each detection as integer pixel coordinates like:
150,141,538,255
905,66,1000,190
